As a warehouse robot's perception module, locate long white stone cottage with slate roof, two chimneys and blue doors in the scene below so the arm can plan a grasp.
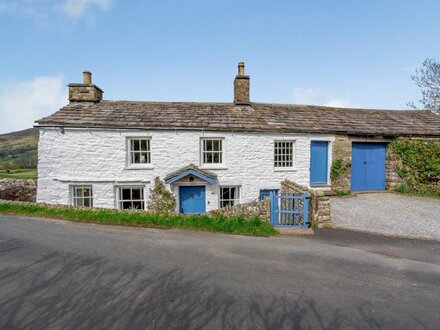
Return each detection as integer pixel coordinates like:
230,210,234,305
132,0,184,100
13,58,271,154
36,63,440,213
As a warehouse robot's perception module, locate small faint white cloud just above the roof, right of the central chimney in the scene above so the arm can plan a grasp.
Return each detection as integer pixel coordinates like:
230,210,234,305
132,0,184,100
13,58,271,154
293,87,353,108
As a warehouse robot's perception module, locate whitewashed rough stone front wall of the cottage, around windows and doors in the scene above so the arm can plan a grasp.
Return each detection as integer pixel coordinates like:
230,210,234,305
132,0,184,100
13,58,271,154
37,128,334,210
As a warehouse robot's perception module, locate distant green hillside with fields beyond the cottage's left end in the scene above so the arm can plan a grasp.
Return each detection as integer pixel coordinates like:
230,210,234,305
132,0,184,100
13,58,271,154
0,128,38,176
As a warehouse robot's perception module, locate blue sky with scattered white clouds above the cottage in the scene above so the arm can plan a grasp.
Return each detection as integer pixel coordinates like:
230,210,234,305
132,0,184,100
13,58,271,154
0,0,440,133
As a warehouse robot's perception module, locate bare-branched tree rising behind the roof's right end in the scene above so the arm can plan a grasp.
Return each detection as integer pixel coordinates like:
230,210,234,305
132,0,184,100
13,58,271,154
408,58,440,115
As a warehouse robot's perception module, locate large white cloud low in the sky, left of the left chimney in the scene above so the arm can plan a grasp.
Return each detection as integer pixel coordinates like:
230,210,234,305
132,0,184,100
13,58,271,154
0,76,67,133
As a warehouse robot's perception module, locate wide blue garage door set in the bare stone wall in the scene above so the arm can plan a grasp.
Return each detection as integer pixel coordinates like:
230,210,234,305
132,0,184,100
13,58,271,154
351,142,386,191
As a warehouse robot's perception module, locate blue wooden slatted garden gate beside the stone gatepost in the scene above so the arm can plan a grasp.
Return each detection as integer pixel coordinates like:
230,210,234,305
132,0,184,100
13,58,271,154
270,192,309,228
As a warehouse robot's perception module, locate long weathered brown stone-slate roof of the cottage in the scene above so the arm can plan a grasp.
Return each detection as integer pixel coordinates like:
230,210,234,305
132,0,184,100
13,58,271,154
37,100,440,136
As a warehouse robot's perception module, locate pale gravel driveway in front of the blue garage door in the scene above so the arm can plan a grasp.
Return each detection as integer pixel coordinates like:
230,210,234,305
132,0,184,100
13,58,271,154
331,193,440,240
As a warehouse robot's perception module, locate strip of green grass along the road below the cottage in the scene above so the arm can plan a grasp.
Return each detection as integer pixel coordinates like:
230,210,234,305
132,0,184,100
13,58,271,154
0,202,276,236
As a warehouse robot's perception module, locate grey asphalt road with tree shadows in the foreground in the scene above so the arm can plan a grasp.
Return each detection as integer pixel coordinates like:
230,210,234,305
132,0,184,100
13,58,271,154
0,215,440,329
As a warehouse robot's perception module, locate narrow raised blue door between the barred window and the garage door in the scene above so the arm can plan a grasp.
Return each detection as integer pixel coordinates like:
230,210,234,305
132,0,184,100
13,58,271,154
310,141,328,185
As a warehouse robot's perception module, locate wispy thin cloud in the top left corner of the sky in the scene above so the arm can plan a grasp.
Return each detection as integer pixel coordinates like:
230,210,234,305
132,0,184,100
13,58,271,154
0,0,111,23
